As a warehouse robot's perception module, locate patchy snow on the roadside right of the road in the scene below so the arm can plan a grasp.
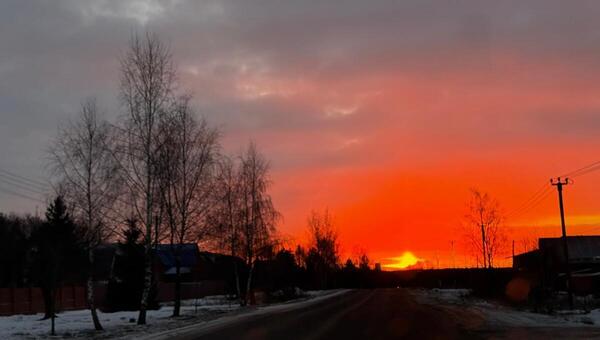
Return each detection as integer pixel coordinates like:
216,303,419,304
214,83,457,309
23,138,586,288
412,289,600,329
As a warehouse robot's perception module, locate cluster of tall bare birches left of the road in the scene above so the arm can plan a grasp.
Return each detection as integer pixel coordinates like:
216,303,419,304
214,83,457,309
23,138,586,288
44,33,279,330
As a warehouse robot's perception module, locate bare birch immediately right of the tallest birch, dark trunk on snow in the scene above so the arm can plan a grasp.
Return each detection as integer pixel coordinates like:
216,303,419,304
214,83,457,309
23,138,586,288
159,97,218,316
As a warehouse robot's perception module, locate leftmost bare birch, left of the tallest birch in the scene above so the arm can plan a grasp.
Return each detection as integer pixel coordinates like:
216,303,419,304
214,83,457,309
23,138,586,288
50,99,120,330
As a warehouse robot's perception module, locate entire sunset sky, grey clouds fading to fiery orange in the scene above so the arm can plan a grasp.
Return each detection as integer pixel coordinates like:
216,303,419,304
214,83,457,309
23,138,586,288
0,0,600,266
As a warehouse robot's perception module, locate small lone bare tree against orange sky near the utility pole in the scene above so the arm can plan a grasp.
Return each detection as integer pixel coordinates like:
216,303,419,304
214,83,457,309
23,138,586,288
465,189,507,268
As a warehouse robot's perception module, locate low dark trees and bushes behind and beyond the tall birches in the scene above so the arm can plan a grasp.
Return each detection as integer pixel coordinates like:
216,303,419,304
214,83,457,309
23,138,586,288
0,201,379,334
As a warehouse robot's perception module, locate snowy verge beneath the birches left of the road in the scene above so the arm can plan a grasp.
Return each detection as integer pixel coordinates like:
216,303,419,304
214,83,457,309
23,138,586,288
0,291,342,340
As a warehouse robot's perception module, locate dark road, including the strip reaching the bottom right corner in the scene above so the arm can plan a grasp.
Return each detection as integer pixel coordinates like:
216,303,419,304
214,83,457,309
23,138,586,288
160,289,600,340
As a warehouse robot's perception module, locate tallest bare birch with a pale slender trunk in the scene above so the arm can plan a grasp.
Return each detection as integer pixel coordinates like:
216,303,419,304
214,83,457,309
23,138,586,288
119,33,176,324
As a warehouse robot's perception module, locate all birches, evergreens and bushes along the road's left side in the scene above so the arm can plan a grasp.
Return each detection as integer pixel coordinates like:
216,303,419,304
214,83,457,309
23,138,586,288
0,33,380,333
